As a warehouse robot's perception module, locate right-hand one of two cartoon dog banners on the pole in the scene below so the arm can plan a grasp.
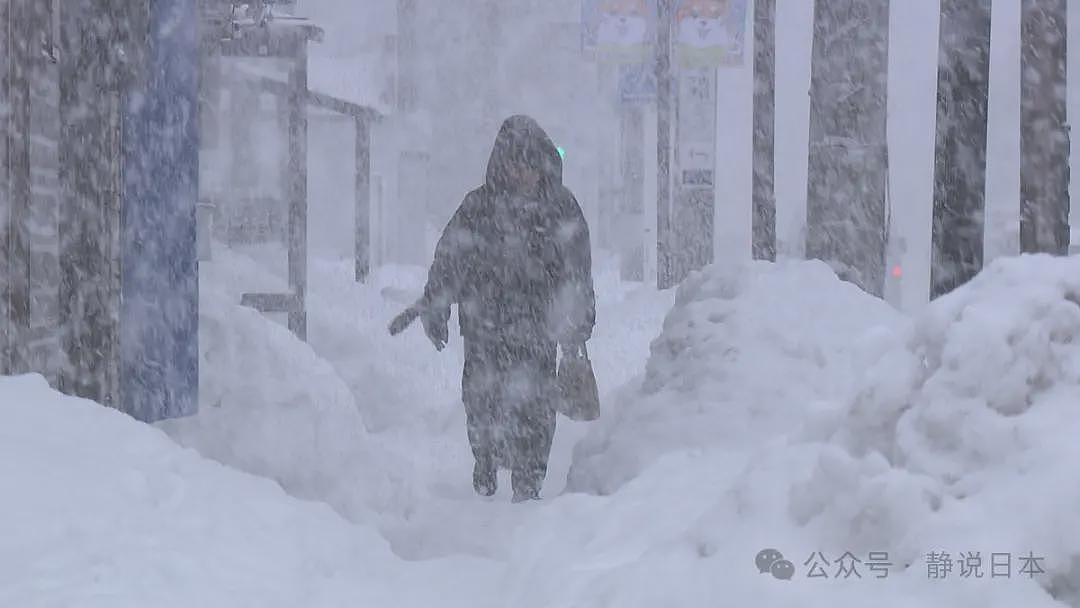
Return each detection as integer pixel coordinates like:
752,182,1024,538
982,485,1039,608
675,0,746,66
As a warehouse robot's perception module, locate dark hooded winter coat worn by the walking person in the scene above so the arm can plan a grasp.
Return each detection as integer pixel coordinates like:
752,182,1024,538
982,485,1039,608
422,116,595,344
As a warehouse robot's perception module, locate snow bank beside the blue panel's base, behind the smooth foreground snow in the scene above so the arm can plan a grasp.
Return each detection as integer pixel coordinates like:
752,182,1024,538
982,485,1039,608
160,252,415,521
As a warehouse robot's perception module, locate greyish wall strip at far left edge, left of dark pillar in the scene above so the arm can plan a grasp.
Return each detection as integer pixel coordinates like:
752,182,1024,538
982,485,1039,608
0,0,62,384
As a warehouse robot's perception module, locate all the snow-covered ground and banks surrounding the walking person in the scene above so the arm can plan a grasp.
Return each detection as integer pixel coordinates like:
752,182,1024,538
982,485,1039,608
0,245,1080,608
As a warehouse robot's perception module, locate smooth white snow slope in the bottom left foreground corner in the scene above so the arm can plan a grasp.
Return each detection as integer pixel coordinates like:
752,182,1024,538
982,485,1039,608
0,376,499,608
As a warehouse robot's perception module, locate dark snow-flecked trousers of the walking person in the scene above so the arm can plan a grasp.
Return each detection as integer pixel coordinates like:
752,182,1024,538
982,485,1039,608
461,334,556,494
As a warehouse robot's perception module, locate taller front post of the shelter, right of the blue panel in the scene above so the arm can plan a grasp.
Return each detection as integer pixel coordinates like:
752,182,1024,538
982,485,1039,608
287,42,308,340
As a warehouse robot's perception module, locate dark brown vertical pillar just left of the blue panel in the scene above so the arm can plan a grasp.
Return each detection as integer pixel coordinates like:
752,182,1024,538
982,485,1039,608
59,0,119,408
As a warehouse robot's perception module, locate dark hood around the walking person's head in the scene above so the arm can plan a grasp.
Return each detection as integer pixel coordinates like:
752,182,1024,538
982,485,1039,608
486,114,563,192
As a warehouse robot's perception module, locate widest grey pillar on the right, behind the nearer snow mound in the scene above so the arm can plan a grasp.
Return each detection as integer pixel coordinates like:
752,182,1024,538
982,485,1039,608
807,0,889,297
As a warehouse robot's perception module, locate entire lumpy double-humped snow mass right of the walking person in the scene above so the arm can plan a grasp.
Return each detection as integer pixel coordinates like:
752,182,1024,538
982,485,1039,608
570,256,1080,606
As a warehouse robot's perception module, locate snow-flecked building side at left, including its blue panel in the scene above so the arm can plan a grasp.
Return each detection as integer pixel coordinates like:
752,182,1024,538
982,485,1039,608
0,0,198,420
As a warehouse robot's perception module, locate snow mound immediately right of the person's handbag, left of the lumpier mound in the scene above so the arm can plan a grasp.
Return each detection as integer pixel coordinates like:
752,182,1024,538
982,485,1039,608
570,261,905,492
